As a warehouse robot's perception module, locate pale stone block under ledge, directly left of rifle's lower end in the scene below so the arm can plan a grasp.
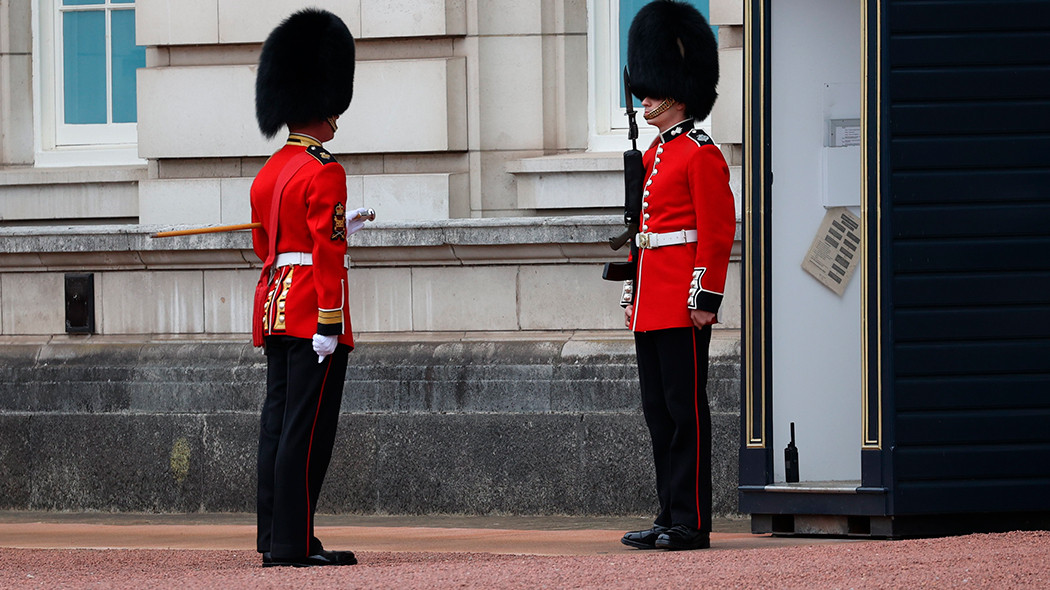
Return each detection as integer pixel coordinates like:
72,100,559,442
519,262,624,330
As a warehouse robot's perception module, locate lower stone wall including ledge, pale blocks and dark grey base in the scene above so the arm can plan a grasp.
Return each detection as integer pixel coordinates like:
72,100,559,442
0,217,739,514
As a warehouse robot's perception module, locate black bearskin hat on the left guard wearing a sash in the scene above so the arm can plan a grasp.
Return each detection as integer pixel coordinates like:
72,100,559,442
255,8,354,138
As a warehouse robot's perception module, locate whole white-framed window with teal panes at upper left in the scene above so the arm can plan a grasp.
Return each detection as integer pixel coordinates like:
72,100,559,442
34,0,146,165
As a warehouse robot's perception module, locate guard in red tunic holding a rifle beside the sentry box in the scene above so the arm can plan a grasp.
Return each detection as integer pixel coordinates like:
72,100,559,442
622,0,736,549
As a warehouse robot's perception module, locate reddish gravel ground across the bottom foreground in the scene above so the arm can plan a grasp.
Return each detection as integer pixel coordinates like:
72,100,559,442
0,531,1050,590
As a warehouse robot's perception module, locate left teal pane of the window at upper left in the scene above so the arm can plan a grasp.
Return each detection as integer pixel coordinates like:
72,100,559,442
62,10,106,125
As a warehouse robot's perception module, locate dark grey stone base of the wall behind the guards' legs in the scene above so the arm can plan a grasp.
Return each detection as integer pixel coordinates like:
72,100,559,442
0,332,739,514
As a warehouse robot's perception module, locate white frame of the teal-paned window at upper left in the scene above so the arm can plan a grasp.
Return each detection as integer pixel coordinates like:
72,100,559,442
32,0,146,167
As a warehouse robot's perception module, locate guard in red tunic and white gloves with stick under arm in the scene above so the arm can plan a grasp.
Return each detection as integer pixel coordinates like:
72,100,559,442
251,9,364,566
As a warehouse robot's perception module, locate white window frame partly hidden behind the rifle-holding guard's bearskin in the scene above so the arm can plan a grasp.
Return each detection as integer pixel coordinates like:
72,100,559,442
587,0,711,151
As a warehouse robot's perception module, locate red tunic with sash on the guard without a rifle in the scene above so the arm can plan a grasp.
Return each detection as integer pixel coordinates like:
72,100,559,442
251,134,354,347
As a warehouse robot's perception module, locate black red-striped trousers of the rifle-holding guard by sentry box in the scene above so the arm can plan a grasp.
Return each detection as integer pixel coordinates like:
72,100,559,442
634,325,711,532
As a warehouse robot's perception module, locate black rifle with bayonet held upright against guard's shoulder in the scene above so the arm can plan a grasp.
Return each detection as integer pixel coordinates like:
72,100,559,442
602,66,646,280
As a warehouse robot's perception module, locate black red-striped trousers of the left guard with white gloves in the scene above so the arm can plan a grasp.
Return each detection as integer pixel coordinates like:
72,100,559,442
256,336,350,559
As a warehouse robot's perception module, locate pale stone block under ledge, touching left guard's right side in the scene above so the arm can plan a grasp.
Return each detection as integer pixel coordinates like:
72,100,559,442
350,265,412,334
